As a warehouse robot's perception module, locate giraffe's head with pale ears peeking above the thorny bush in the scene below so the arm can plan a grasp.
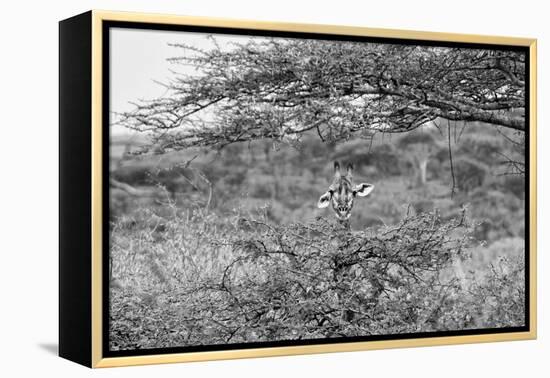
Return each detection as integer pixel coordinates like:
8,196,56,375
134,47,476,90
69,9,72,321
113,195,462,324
317,161,374,221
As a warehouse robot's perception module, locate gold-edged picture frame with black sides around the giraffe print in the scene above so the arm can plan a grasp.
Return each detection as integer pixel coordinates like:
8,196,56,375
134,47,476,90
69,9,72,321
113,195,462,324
60,10,537,368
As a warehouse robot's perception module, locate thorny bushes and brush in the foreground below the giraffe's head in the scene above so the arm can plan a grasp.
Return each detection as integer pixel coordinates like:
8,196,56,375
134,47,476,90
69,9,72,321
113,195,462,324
110,207,524,350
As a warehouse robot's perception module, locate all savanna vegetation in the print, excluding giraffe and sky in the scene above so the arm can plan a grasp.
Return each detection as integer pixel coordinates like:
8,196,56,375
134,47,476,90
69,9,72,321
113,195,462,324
110,40,525,350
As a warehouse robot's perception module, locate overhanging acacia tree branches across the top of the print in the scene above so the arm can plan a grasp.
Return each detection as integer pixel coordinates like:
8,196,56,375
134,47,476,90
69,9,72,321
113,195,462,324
118,38,525,152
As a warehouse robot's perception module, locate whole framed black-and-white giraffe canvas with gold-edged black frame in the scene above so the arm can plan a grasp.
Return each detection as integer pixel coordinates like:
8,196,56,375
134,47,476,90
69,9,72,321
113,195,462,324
59,11,536,367
